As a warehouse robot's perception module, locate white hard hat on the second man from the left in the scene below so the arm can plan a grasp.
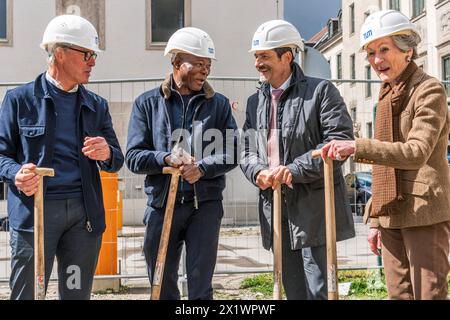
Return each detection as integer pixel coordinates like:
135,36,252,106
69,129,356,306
164,27,216,60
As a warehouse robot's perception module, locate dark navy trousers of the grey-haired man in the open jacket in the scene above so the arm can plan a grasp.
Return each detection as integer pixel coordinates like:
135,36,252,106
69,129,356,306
10,198,102,300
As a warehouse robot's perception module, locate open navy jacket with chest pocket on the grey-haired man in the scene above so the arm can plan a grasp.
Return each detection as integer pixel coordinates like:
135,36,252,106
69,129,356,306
0,74,124,234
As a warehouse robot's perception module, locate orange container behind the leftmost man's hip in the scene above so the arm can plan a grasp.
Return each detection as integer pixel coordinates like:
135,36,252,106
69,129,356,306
95,171,118,275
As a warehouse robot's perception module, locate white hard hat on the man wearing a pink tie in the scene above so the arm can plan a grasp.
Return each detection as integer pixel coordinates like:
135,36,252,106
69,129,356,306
249,20,304,52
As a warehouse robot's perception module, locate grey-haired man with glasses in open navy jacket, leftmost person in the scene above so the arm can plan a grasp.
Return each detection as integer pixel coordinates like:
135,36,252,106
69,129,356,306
0,15,124,299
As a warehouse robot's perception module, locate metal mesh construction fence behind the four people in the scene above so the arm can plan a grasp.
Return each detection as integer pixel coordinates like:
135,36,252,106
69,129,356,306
0,77,450,282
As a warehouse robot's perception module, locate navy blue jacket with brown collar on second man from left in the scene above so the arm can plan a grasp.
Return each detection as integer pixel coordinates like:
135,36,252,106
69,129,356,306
125,77,238,208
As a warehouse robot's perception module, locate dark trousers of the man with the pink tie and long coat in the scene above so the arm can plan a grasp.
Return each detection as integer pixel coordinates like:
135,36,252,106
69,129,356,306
281,207,328,300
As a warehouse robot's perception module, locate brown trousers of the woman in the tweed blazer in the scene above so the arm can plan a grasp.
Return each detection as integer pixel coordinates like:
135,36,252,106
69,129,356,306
380,221,450,300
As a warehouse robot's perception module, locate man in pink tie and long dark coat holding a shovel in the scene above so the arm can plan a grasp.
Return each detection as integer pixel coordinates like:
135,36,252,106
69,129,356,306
241,20,355,300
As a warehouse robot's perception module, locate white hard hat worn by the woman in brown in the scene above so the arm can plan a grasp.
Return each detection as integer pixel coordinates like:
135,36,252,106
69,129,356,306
360,10,420,50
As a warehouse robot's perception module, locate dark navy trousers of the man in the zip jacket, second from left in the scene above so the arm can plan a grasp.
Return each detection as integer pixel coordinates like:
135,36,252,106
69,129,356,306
144,201,223,300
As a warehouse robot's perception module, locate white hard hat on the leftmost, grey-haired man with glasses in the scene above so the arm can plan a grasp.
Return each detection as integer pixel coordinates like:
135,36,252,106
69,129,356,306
41,14,101,52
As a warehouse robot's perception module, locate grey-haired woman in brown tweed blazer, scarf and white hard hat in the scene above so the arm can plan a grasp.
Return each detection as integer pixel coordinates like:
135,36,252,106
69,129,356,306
322,10,450,299
